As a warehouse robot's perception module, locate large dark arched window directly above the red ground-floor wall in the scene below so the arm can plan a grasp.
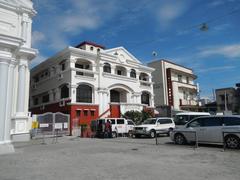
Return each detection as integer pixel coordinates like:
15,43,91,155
77,84,92,103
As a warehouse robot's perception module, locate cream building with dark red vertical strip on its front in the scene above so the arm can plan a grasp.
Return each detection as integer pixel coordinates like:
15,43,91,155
148,60,198,114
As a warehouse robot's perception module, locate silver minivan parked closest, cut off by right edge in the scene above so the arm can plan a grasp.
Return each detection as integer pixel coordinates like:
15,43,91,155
170,116,240,149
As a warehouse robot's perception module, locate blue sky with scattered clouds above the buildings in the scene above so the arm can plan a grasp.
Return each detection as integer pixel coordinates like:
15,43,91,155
32,0,240,97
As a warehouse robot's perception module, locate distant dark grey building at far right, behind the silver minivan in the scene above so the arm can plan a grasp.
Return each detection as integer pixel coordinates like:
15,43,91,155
215,84,240,113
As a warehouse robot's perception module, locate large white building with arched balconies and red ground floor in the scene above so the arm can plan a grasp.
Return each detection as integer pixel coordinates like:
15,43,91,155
30,42,154,131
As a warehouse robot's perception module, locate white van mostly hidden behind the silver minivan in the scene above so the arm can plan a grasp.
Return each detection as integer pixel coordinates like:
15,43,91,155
174,112,210,126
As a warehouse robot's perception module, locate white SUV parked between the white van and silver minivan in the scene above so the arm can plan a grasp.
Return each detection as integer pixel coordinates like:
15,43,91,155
133,117,175,138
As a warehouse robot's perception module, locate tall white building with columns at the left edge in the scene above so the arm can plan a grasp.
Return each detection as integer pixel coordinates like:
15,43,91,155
0,0,37,153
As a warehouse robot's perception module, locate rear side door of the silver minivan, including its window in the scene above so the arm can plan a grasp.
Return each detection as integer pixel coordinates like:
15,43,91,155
200,117,223,143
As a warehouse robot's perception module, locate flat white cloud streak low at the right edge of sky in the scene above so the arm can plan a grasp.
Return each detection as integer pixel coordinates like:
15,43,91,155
199,43,240,58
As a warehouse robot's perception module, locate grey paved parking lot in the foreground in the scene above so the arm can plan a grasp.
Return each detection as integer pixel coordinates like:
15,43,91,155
0,137,240,180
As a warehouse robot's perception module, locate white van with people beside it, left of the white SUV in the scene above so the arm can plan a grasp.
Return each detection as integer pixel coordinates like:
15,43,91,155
92,118,135,137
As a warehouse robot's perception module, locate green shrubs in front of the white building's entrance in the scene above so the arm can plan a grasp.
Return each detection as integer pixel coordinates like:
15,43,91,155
122,110,152,124
